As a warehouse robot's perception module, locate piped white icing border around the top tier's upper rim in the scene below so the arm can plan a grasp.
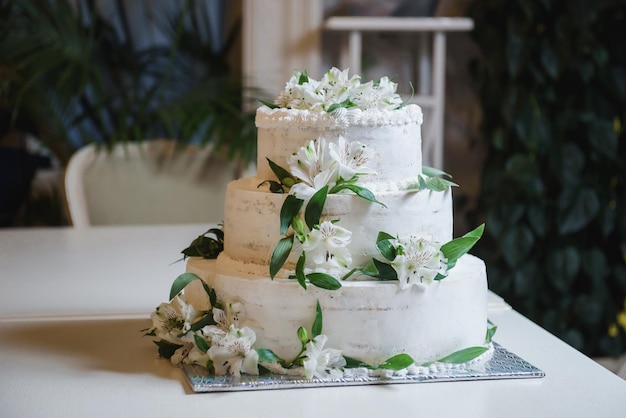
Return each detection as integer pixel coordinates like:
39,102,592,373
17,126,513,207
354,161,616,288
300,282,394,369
256,104,424,130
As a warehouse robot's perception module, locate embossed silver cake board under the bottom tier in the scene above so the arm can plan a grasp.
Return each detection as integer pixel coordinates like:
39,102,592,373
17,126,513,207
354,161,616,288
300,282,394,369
183,342,545,393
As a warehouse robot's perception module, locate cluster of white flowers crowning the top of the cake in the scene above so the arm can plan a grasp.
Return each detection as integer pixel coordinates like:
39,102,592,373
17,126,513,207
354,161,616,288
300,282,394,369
264,67,403,112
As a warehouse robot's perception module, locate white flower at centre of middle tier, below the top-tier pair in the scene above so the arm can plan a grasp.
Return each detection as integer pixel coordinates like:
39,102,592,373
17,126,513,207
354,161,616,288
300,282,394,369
302,221,352,268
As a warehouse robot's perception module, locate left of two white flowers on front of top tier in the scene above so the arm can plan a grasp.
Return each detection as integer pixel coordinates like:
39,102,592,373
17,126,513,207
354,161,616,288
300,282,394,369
287,137,337,200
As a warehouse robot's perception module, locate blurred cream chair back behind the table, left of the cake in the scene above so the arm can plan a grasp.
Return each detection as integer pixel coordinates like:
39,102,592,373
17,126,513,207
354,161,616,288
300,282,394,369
64,139,249,228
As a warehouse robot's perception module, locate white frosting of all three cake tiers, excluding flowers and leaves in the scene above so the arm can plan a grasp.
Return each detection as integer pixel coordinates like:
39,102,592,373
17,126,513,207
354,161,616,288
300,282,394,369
182,105,487,365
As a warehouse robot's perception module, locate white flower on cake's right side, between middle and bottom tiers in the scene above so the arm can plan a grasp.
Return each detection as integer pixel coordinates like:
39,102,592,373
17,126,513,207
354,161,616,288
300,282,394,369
391,236,448,289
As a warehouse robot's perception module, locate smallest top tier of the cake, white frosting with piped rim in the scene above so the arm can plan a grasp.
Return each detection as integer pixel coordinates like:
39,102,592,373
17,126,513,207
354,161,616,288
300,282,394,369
256,104,422,191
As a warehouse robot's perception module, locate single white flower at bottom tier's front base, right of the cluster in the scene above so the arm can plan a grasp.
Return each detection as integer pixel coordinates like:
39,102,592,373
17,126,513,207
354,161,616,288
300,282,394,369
303,335,346,379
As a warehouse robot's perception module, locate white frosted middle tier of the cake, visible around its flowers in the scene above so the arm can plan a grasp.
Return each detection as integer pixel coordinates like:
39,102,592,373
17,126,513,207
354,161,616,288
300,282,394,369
220,178,452,276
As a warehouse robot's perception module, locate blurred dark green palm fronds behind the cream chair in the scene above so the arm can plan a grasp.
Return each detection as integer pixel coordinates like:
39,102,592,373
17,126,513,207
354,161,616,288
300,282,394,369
0,0,256,226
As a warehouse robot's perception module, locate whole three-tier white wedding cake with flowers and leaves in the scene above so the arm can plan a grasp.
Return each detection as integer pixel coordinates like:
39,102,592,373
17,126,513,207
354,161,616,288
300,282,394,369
150,68,492,379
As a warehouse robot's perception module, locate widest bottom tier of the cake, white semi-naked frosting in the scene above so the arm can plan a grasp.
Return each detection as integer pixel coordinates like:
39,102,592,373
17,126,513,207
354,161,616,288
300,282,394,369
186,254,487,366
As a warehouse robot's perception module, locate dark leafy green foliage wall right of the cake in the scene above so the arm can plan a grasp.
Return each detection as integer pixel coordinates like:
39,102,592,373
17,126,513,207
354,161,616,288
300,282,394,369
470,0,626,356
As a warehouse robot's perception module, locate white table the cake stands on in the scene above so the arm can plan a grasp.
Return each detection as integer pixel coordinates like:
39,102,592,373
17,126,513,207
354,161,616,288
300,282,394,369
0,225,626,418
